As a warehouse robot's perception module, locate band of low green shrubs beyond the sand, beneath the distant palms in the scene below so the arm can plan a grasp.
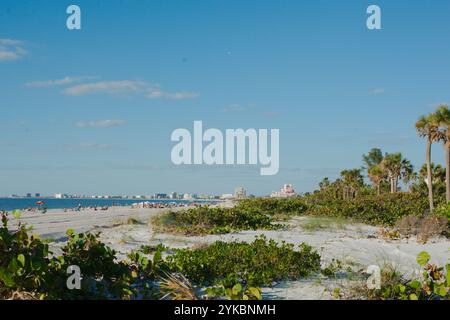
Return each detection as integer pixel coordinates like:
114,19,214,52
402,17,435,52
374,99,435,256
153,189,450,236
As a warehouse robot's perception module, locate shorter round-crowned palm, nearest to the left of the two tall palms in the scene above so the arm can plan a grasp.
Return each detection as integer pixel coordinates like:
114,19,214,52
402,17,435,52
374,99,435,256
380,153,414,193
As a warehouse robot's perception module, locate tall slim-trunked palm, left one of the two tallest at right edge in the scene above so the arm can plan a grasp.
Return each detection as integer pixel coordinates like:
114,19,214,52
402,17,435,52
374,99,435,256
416,114,441,212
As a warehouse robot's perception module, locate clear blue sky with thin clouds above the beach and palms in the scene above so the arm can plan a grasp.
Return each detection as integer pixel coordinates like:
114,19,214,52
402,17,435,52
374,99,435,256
0,0,450,195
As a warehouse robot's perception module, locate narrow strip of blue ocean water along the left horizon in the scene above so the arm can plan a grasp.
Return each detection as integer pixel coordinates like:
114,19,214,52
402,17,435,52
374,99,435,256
0,198,204,211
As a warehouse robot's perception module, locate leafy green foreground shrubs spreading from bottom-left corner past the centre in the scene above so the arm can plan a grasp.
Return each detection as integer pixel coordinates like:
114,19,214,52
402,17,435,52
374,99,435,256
0,214,320,299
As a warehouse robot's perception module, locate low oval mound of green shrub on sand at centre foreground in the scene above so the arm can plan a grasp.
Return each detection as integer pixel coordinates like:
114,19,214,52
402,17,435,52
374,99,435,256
163,236,320,287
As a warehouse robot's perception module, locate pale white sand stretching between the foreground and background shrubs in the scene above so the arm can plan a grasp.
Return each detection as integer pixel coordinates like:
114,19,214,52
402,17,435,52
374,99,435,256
7,207,450,299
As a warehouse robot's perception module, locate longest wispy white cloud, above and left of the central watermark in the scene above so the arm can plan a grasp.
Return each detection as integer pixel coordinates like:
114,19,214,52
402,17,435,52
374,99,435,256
63,80,198,100
